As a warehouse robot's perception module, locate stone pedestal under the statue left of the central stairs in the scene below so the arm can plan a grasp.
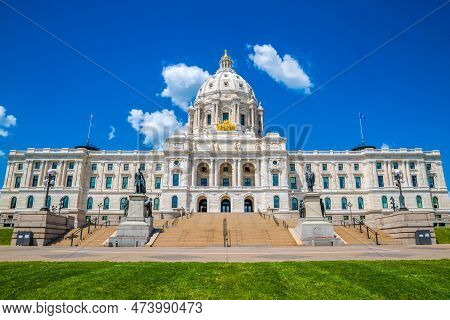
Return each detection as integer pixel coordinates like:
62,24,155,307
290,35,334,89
108,194,153,247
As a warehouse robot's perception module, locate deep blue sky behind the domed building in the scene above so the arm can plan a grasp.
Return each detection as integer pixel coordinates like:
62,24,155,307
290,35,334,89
0,0,450,186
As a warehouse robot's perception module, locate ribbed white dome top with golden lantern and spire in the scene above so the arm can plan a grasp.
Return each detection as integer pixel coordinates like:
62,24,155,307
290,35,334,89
197,50,256,101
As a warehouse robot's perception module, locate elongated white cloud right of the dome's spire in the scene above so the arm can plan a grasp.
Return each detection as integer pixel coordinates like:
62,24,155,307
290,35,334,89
248,44,313,93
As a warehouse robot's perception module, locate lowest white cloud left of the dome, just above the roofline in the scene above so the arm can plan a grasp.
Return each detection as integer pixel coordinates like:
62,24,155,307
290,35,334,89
128,109,185,149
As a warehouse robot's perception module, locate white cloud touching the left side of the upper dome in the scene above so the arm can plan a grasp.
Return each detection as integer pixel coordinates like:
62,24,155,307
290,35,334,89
161,63,209,111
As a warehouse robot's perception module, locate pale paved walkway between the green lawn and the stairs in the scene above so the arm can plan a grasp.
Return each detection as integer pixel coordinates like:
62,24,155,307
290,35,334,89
0,245,450,262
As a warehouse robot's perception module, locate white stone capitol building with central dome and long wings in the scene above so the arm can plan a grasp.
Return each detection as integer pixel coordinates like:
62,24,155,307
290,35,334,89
0,53,450,224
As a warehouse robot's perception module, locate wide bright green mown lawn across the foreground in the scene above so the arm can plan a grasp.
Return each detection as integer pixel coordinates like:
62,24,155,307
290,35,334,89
0,260,450,300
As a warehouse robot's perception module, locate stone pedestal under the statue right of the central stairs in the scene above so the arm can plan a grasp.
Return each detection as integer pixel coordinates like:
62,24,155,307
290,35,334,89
295,192,340,246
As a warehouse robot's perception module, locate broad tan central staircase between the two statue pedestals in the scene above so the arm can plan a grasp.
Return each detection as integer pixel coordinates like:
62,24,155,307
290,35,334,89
153,213,297,247
